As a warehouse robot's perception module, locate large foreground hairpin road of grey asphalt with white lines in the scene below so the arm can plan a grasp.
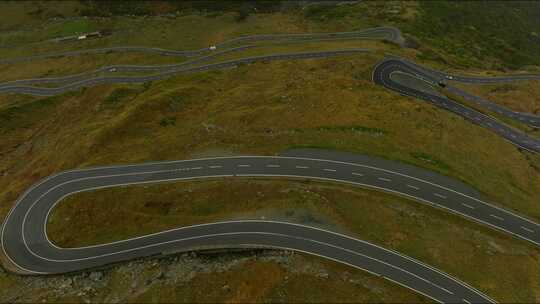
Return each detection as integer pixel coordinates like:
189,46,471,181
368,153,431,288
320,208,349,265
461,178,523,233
1,149,540,303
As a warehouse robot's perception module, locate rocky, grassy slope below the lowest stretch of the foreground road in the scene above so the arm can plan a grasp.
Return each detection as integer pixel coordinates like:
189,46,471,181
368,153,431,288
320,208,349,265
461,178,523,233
0,251,429,303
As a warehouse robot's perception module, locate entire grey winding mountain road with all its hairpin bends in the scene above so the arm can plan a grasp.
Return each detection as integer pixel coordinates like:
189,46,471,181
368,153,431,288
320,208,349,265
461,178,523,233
0,27,540,303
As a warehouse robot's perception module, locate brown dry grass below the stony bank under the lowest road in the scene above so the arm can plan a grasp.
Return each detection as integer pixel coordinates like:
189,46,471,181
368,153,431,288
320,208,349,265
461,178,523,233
124,252,428,303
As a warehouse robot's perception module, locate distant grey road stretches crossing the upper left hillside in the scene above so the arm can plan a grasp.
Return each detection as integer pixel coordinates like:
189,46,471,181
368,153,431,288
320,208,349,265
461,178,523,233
0,27,405,96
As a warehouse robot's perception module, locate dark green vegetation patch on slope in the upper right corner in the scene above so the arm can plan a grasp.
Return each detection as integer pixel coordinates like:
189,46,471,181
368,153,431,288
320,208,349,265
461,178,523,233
400,1,540,69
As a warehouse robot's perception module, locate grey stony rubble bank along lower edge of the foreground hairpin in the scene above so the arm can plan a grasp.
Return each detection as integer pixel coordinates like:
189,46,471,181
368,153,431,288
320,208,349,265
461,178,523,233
0,250,358,303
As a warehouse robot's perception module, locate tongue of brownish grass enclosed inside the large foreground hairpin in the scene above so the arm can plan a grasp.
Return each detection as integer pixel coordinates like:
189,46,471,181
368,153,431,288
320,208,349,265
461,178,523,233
48,178,540,303
